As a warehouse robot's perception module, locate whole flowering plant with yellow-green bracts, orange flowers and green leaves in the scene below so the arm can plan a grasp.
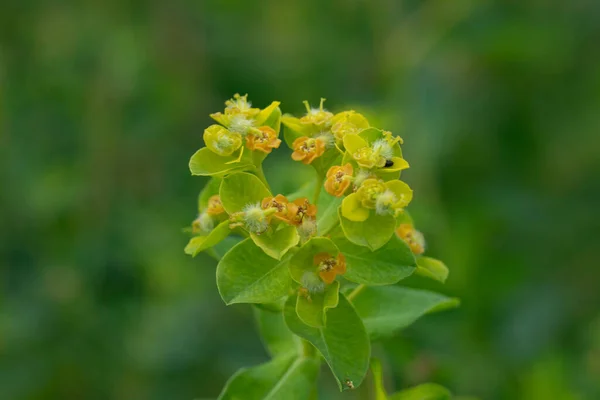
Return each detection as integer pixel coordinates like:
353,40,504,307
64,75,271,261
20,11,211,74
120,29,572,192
185,94,457,400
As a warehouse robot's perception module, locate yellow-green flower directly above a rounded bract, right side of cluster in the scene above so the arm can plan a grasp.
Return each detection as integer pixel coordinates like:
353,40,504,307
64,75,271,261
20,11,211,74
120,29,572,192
342,179,412,222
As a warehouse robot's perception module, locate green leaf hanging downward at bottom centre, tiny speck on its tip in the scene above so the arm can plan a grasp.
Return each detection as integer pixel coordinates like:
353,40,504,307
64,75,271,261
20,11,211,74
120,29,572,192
284,296,371,390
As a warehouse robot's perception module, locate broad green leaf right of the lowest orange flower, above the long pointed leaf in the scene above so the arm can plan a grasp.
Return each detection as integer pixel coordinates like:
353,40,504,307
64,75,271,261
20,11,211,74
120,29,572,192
333,235,415,285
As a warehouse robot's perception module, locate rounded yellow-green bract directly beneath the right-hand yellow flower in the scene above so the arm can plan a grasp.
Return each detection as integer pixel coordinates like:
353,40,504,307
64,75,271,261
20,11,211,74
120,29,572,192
339,210,396,251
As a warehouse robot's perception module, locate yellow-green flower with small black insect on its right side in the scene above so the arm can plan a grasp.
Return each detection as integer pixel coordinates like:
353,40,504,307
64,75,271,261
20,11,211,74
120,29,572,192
344,130,409,172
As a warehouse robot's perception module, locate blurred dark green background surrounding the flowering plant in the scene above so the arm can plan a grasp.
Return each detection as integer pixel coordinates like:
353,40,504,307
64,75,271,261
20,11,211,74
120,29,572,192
0,0,600,400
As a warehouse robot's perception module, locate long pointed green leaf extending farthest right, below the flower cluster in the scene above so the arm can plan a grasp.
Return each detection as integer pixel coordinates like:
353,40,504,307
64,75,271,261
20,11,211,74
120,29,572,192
352,286,459,339
